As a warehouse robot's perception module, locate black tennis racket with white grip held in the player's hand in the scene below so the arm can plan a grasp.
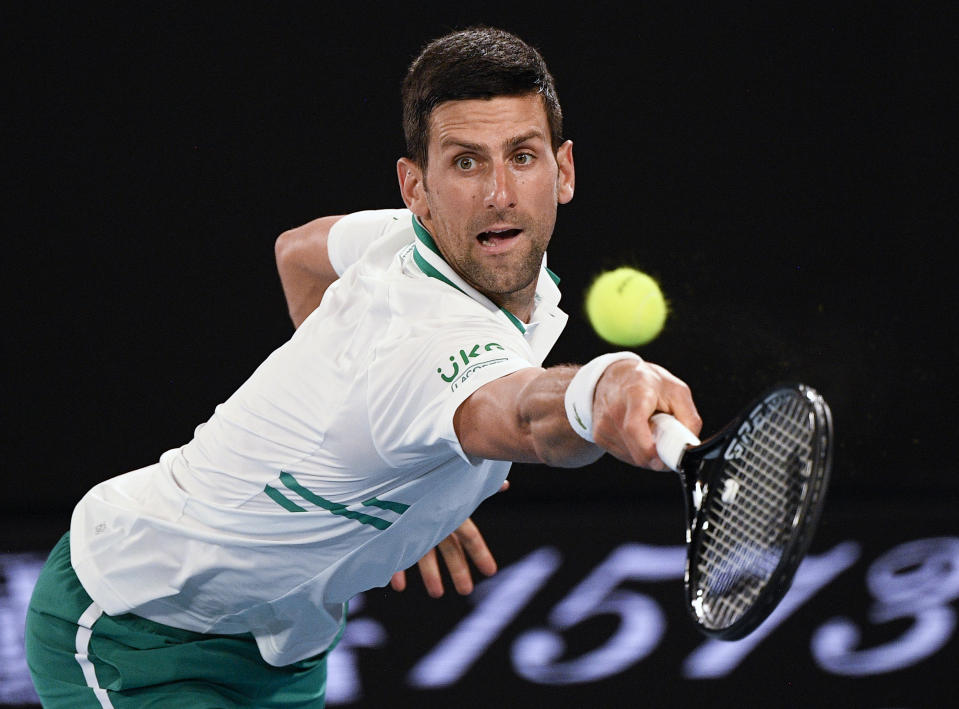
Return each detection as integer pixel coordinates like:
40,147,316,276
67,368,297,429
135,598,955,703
651,384,833,640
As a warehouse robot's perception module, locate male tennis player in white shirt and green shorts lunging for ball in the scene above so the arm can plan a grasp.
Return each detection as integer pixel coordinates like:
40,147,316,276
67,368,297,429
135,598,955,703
27,28,700,707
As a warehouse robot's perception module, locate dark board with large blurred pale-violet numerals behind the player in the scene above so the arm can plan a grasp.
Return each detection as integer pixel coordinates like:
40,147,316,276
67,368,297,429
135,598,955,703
0,493,959,707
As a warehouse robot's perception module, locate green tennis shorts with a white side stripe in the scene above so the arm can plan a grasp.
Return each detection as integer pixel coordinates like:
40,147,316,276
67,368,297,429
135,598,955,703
26,532,326,709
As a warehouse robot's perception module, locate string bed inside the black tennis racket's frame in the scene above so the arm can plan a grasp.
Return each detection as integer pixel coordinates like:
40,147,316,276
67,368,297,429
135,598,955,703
693,395,814,628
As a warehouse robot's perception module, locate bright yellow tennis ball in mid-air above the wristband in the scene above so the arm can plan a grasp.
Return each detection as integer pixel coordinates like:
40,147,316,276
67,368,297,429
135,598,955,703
586,266,667,347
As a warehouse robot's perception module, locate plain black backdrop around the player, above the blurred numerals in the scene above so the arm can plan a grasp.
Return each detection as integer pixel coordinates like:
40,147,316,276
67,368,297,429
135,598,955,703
0,2,959,706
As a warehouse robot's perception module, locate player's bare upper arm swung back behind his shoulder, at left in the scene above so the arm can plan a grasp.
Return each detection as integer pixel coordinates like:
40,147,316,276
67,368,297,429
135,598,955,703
274,216,342,327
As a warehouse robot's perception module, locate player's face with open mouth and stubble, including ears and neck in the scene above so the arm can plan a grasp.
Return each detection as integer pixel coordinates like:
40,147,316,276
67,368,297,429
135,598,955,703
400,94,574,319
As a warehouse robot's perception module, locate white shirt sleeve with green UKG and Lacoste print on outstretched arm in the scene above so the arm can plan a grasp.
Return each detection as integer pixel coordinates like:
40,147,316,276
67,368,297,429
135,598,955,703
369,323,536,467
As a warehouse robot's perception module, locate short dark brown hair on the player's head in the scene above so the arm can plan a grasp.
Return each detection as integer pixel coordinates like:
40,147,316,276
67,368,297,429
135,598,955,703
403,26,563,167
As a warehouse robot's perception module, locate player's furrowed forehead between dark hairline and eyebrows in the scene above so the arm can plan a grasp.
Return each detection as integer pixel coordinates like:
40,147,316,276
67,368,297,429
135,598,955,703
430,93,549,152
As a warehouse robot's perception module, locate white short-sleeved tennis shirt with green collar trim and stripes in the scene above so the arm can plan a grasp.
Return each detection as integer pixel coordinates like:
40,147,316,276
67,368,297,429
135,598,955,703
71,210,566,665
